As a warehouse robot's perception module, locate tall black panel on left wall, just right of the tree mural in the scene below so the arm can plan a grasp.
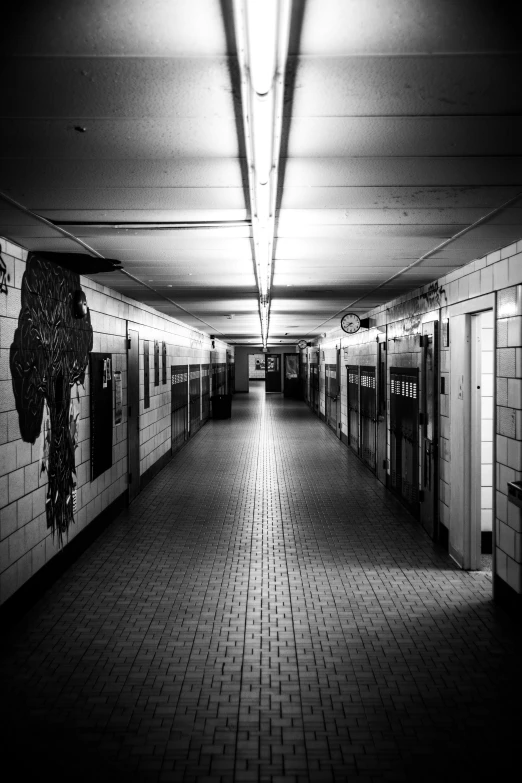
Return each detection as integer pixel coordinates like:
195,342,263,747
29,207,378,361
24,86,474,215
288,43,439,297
90,353,113,481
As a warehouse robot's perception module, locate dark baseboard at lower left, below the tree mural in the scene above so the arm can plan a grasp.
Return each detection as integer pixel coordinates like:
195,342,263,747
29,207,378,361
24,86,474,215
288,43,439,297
0,490,129,627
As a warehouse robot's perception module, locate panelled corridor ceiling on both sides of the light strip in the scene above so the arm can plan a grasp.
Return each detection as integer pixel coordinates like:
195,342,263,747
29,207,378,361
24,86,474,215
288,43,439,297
0,0,522,345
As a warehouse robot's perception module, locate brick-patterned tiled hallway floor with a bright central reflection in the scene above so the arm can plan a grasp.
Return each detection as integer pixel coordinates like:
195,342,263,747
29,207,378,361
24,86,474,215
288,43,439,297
1,389,522,783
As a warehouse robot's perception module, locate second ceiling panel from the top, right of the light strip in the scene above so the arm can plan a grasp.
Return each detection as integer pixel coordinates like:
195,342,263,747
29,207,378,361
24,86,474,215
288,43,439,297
287,53,522,118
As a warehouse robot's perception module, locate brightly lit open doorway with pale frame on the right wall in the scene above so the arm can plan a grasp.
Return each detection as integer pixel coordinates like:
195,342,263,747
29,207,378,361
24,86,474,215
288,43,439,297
449,310,494,571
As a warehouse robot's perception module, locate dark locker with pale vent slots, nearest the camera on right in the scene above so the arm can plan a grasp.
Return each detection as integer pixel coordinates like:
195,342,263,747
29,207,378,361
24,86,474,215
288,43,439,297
390,367,419,517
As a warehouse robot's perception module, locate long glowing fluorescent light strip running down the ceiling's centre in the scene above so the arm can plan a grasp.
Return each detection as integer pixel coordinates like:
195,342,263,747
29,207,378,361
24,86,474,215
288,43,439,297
234,0,292,348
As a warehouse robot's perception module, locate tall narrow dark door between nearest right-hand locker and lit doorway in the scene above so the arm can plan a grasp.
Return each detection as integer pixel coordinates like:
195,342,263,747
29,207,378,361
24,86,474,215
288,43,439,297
420,321,439,538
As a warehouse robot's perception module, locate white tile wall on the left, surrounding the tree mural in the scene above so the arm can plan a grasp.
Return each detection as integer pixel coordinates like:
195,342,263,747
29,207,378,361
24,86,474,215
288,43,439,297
0,238,227,602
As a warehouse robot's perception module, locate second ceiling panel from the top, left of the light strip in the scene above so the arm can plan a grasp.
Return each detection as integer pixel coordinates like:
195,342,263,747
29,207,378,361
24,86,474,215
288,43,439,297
2,57,238,122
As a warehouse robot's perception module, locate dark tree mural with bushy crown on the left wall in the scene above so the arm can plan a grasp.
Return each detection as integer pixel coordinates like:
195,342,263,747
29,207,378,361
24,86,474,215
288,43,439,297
10,253,92,543
